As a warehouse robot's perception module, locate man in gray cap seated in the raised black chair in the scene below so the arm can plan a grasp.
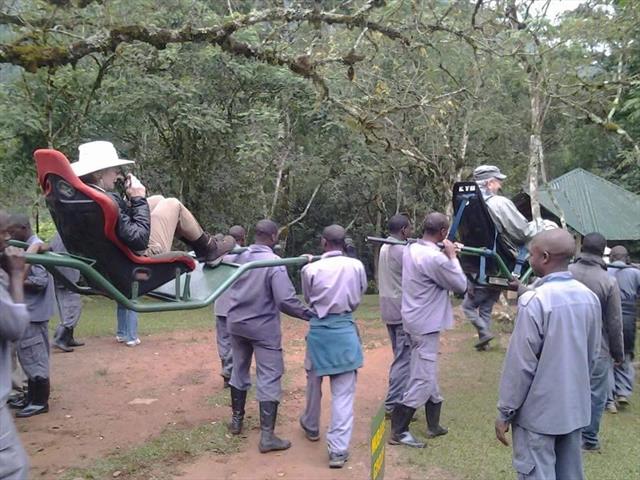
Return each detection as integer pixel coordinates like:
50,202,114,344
473,165,538,257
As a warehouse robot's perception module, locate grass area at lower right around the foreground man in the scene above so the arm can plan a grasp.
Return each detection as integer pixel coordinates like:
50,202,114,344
401,318,640,480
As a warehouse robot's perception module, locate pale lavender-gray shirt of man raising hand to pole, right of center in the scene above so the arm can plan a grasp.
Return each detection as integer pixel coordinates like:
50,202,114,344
402,240,467,335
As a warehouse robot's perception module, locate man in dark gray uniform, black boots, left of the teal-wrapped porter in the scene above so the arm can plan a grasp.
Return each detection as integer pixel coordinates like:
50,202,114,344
227,220,312,453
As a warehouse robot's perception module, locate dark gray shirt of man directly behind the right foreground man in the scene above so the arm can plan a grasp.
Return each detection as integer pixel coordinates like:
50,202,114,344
569,252,624,362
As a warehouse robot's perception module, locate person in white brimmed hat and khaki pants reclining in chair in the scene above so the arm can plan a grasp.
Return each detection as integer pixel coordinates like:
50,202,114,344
71,141,235,265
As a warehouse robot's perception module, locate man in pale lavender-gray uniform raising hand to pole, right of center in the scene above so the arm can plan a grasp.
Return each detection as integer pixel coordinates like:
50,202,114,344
389,212,467,448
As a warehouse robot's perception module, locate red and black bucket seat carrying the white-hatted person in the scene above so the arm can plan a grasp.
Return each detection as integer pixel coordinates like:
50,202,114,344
34,149,196,298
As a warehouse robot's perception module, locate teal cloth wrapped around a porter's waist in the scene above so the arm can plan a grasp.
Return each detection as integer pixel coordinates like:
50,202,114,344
307,313,363,377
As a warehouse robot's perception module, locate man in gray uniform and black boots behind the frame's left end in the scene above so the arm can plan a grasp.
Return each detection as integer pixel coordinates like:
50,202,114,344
9,215,54,417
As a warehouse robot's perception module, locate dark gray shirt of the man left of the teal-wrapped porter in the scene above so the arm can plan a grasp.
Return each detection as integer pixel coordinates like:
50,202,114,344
227,245,313,343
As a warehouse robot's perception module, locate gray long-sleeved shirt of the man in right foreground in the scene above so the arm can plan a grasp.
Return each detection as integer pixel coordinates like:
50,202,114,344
498,272,602,435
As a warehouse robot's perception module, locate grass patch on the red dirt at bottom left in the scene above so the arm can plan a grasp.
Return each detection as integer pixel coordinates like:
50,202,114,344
62,422,241,480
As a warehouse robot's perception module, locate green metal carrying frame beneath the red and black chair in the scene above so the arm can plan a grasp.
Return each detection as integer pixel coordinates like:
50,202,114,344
18,241,320,313
